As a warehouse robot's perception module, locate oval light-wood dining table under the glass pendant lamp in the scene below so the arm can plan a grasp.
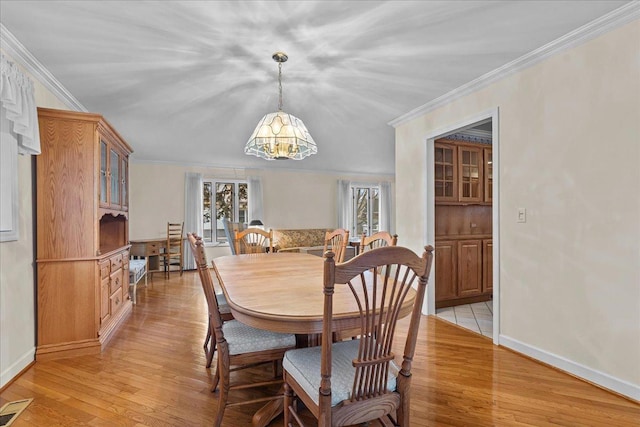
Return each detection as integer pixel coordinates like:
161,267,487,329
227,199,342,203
213,252,415,426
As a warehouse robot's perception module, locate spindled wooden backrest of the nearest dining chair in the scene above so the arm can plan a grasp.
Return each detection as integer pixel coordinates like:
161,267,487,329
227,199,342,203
319,246,433,412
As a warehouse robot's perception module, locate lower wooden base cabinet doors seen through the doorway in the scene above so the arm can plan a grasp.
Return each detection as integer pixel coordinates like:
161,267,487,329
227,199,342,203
435,239,493,308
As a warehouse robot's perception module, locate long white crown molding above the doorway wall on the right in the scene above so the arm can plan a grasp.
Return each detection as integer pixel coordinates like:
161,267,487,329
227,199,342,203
387,0,640,128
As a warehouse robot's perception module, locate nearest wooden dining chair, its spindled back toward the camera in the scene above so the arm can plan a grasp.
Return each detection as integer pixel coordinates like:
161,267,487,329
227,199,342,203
282,246,433,427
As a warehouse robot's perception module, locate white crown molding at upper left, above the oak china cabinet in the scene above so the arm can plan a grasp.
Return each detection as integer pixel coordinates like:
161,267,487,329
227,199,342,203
0,23,88,111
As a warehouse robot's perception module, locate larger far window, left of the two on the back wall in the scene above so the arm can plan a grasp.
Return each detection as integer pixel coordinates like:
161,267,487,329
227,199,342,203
202,180,249,243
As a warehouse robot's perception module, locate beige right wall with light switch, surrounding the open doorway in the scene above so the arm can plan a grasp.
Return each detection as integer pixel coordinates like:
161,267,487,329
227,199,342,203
396,20,640,398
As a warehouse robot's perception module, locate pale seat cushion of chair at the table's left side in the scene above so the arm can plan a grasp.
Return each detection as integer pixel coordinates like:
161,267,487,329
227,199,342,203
222,320,296,355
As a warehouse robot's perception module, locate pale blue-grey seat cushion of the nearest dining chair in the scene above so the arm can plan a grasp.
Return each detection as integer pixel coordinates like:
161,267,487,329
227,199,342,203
282,340,399,406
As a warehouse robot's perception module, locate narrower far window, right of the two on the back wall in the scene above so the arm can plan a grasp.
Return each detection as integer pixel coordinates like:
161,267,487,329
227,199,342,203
349,185,380,237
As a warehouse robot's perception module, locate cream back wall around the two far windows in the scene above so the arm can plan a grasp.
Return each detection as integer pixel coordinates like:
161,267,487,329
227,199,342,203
129,163,393,258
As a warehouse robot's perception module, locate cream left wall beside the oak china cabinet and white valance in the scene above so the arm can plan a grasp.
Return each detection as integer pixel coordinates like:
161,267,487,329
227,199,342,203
0,51,68,387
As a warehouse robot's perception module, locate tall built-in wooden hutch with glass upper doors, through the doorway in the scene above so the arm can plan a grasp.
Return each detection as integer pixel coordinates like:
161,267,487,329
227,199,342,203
434,139,493,308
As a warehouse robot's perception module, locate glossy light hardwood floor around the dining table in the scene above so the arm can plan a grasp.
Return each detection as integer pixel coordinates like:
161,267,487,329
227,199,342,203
0,272,640,427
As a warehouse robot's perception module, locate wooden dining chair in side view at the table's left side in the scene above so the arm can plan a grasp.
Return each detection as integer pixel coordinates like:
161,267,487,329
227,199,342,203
188,233,296,427
